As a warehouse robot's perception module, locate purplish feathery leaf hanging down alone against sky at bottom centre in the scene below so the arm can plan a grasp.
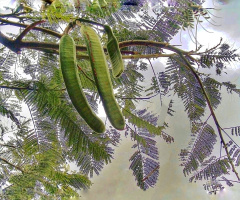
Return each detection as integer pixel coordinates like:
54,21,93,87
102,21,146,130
123,109,172,190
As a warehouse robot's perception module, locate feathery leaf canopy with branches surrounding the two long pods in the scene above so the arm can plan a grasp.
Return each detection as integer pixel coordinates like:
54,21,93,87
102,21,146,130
0,0,240,199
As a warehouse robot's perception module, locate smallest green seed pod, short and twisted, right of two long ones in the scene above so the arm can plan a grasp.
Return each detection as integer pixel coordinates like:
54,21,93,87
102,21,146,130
104,25,124,77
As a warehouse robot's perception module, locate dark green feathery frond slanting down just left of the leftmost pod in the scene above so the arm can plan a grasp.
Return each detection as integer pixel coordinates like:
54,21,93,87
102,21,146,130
12,79,110,162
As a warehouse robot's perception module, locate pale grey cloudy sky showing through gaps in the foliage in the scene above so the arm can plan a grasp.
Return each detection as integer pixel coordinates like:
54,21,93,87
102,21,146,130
1,0,240,200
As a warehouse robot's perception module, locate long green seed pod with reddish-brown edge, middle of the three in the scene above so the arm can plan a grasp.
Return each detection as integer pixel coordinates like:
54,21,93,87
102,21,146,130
80,25,125,130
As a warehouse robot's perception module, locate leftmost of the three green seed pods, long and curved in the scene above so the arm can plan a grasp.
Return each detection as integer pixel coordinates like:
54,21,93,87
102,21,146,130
59,35,105,133
